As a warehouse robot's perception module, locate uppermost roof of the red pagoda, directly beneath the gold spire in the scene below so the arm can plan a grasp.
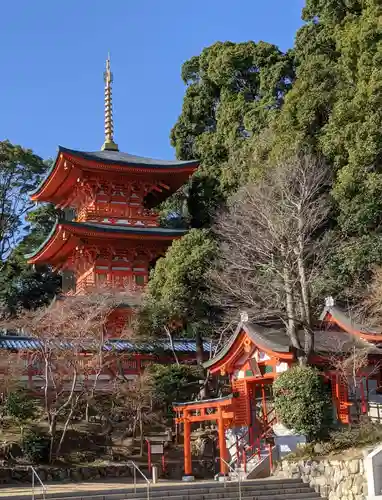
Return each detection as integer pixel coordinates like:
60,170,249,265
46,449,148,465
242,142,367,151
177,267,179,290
31,146,198,205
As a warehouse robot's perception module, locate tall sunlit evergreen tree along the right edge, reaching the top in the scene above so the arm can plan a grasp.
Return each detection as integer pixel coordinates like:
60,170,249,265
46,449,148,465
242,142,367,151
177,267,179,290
262,0,382,301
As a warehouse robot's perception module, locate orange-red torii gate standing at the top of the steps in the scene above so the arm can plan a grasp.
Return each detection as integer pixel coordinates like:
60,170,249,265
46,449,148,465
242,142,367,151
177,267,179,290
173,396,234,476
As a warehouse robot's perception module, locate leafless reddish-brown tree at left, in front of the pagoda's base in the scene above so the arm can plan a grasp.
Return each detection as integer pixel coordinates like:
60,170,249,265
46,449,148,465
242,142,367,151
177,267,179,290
2,289,134,460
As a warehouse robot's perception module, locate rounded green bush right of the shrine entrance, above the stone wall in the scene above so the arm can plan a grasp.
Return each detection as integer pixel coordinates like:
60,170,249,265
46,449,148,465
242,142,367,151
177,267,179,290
273,366,332,440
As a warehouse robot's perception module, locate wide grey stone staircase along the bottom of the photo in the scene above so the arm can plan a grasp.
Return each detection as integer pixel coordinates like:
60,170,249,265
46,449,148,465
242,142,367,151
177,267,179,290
8,479,321,500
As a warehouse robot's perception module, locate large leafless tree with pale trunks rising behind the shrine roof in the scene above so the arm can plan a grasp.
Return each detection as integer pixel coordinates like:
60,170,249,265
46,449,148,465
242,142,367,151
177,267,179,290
211,156,330,363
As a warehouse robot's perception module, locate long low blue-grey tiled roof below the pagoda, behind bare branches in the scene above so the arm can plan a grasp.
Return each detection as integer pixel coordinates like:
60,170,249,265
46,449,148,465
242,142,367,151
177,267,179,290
0,335,211,354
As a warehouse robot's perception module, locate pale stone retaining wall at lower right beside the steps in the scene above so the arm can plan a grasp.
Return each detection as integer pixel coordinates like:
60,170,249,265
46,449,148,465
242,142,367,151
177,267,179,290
273,458,367,500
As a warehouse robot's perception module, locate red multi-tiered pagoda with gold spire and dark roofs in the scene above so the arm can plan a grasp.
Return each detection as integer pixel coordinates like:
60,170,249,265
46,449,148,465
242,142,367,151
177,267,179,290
27,58,198,332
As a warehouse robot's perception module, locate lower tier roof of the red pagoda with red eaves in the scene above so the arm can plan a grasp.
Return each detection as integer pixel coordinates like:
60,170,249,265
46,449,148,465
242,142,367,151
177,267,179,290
25,220,187,266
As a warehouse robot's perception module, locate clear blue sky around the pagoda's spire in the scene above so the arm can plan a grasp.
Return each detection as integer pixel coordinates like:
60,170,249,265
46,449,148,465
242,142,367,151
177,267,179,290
0,0,305,159
